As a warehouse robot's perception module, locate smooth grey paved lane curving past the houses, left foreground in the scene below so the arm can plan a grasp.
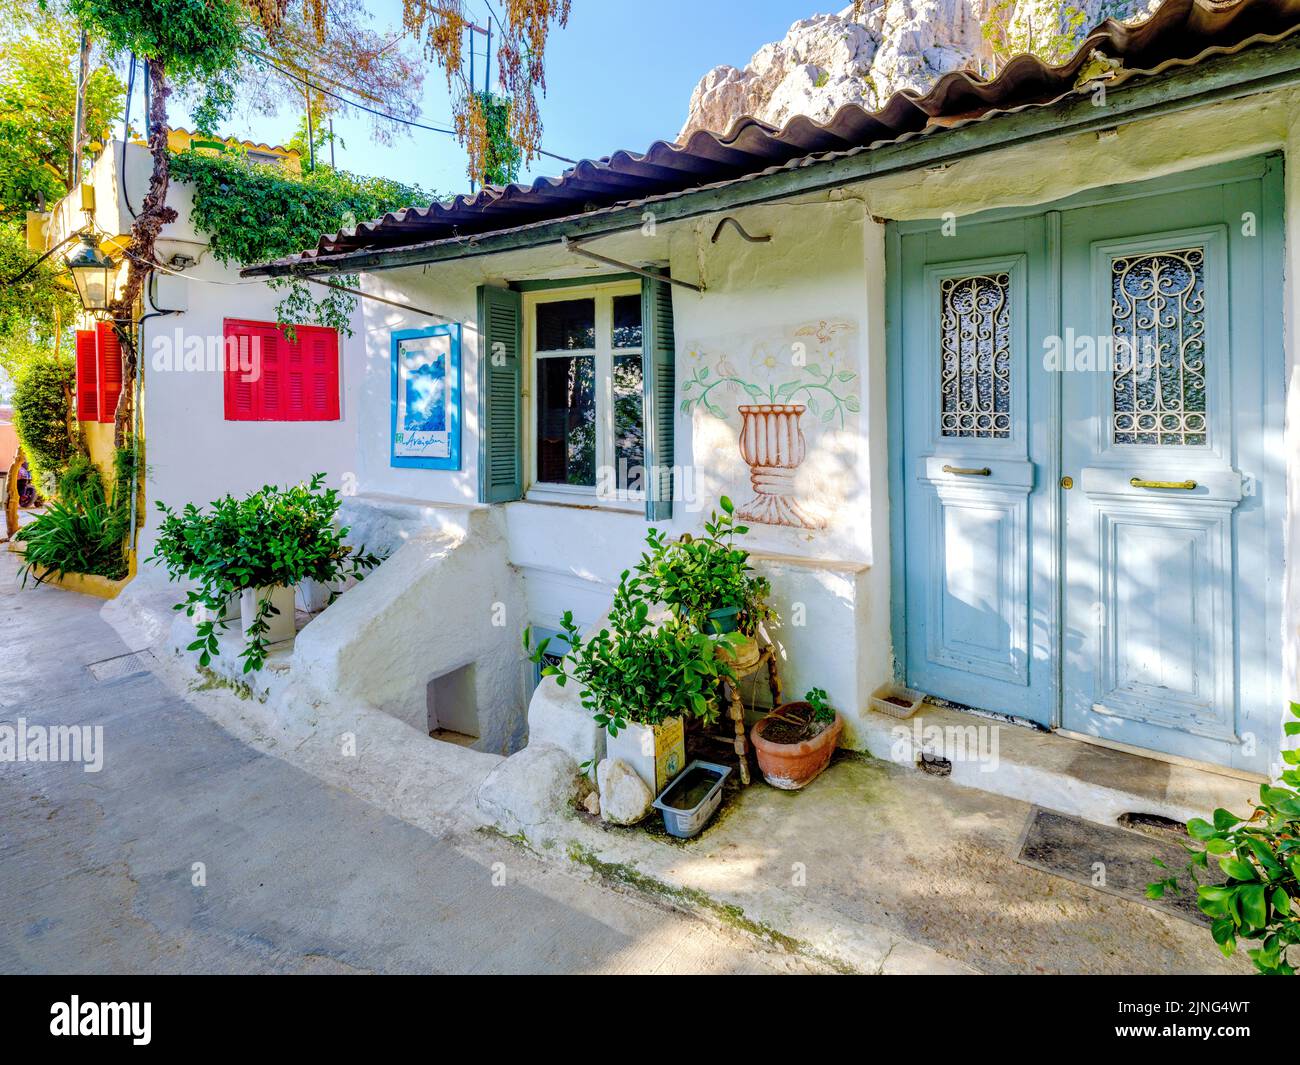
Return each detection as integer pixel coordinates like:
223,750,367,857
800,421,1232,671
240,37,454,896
0,547,816,973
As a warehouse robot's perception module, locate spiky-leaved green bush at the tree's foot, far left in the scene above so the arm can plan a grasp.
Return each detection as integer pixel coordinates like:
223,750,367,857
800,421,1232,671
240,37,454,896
14,455,130,585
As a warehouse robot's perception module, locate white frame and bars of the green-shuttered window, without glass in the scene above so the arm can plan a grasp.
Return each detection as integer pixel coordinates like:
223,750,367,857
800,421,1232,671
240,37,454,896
523,280,645,511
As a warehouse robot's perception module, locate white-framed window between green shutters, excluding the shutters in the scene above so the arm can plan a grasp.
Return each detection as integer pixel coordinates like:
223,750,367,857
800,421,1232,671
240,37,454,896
524,281,646,502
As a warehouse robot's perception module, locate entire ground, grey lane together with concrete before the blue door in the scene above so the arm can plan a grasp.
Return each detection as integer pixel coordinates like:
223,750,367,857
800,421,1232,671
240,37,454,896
0,551,1251,974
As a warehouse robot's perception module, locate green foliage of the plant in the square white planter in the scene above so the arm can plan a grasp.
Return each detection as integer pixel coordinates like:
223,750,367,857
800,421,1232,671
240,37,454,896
524,571,736,736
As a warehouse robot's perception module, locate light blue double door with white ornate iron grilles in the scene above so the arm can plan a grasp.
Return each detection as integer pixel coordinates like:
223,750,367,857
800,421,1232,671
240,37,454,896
891,159,1286,772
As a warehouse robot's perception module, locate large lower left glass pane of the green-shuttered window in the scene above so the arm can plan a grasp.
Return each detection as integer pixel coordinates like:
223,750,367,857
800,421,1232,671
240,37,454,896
537,355,595,488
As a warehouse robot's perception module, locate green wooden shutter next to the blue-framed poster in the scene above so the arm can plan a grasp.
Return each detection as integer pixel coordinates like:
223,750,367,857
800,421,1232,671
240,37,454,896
478,285,524,503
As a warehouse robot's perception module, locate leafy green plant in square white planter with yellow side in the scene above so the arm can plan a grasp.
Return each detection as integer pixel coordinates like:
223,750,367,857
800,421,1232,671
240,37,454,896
524,571,735,795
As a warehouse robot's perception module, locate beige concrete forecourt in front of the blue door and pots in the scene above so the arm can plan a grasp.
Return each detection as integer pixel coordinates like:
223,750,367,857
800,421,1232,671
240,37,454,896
621,752,1253,975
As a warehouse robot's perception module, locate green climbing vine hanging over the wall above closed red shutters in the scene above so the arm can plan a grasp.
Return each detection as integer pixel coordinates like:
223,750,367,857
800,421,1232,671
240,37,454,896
172,151,436,335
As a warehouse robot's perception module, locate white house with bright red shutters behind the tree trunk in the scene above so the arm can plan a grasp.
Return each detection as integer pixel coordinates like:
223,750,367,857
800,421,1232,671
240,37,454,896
46,130,361,559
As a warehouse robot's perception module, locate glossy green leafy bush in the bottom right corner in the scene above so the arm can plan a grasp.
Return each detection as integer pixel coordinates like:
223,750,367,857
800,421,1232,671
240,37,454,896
1147,702,1300,975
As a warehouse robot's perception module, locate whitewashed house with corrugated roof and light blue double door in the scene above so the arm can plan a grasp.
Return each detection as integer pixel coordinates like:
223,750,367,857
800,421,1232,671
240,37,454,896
246,0,1300,810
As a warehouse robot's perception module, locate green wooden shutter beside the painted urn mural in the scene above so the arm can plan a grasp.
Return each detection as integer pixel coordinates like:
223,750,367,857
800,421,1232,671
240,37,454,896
641,278,677,521
